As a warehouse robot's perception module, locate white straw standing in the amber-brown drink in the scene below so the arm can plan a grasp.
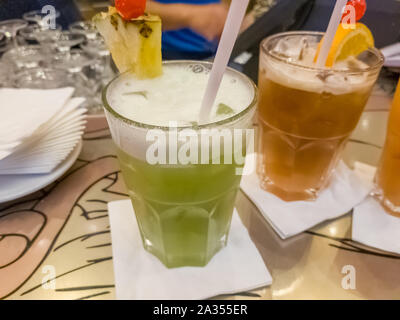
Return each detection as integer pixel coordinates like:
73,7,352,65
317,0,347,68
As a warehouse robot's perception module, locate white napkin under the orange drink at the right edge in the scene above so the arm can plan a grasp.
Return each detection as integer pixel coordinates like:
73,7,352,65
352,197,400,254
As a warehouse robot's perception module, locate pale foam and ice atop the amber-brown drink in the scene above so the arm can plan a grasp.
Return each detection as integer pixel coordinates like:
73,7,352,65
261,36,375,95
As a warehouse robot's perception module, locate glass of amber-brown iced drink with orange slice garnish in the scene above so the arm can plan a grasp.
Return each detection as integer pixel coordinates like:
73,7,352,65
257,32,383,201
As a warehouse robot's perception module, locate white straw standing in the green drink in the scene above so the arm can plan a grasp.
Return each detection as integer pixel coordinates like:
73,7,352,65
200,0,249,124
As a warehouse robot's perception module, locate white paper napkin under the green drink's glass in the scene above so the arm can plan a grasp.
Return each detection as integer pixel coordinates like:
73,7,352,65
108,200,272,300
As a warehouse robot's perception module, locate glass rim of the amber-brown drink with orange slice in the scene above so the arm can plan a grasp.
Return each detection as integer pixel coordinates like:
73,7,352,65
260,31,385,74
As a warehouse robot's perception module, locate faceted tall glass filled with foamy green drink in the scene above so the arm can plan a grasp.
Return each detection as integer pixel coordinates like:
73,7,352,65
103,61,257,267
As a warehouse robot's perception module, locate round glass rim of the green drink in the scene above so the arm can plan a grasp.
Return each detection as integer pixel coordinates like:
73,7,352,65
102,60,258,131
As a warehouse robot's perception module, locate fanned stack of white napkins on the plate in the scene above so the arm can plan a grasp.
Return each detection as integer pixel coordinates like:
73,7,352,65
0,88,86,175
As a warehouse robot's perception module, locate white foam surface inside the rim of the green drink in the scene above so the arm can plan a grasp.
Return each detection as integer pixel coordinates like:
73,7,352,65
107,64,254,126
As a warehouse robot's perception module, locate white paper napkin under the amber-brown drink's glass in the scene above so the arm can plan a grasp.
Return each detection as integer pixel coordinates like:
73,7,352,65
240,158,372,239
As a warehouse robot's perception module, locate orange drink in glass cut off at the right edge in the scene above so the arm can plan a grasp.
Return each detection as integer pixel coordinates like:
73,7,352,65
376,81,400,217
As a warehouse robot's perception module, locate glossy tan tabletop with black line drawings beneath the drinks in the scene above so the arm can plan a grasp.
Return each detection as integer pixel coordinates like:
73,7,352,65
0,75,400,299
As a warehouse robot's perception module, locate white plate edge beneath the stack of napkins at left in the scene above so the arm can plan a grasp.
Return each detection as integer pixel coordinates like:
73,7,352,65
0,141,82,203
